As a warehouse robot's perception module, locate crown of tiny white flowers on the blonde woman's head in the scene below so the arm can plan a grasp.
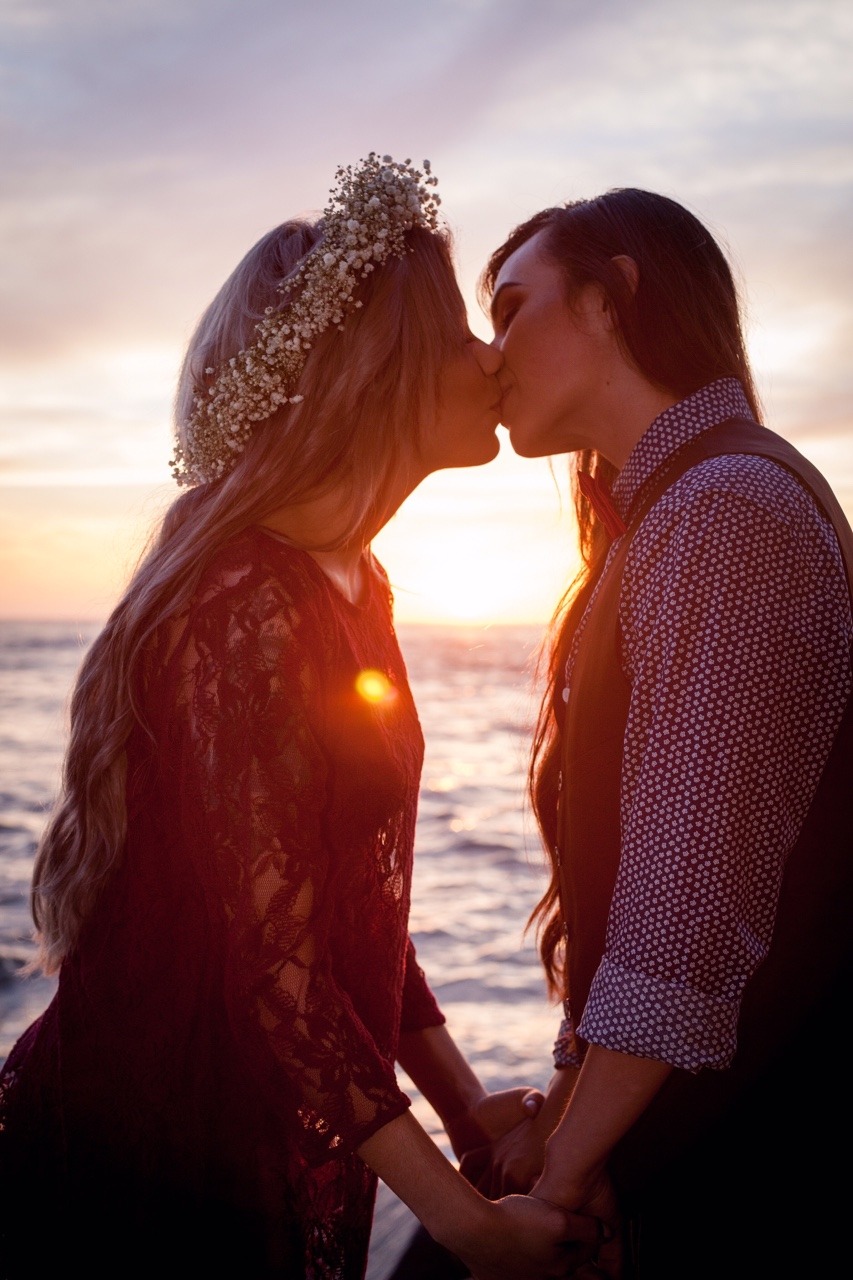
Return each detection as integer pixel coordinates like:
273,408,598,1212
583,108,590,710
170,151,441,485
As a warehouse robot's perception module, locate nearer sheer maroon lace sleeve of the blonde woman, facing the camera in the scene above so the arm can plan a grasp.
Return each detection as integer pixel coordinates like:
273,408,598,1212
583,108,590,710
171,591,409,1164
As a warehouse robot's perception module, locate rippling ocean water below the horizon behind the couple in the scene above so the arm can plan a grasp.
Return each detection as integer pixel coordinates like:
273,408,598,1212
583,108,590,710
0,621,560,1280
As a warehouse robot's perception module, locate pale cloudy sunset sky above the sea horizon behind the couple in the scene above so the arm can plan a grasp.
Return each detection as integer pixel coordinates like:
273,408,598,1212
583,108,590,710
0,0,853,622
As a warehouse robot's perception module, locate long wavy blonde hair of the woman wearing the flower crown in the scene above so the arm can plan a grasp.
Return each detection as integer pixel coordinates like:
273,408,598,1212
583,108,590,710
28,220,467,974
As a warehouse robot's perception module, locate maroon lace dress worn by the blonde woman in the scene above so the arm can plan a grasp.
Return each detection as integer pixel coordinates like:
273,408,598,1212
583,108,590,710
0,529,443,1280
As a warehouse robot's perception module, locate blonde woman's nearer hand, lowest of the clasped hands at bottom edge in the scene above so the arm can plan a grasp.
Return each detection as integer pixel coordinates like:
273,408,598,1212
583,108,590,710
455,1196,601,1280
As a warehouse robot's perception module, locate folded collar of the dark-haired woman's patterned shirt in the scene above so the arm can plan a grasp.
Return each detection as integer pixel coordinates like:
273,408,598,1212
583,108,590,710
613,378,753,518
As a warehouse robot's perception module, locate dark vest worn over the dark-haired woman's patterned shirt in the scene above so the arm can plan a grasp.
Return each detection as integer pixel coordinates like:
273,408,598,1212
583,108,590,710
560,419,853,1194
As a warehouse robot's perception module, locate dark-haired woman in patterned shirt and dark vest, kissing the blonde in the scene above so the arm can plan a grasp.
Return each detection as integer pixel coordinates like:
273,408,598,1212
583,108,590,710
479,188,853,1280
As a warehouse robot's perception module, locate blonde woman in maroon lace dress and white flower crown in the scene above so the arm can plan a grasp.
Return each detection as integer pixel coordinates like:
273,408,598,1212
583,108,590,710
0,154,597,1280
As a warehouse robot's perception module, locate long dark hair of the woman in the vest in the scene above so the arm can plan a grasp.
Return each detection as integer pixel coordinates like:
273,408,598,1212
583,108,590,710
480,187,761,993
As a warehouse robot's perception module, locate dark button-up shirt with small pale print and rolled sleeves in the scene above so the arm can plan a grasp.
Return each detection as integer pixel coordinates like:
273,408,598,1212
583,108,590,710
555,379,853,1071
